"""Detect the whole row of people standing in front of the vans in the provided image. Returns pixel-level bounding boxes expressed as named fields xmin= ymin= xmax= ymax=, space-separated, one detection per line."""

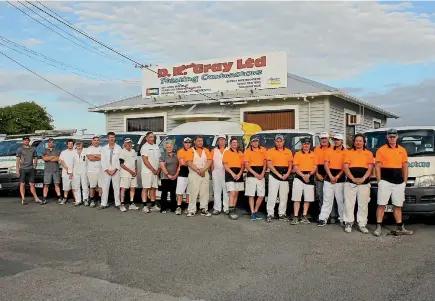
xmin=17 ymin=130 xmax=413 ymax=236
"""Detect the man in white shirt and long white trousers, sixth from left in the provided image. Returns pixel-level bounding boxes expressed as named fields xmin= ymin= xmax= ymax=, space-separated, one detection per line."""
xmin=98 ymin=132 xmax=122 ymax=209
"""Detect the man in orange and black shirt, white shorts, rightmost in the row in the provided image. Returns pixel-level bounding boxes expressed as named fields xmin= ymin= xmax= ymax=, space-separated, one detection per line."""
xmin=374 ymin=129 xmax=414 ymax=236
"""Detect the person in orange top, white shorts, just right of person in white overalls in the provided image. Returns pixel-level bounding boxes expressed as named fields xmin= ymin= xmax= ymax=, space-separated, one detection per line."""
xmin=222 ymin=138 xmax=245 ymax=220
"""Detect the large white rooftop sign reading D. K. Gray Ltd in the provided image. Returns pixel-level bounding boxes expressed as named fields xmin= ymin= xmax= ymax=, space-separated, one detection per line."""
xmin=142 ymin=52 xmax=287 ymax=98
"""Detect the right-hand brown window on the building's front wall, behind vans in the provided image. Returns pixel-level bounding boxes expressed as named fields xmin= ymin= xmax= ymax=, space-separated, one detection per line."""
xmin=244 ymin=110 xmax=295 ymax=130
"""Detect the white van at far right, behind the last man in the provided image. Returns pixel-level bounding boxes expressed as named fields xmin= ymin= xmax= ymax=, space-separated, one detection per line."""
xmin=364 ymin=126 xmax=435 ymax=215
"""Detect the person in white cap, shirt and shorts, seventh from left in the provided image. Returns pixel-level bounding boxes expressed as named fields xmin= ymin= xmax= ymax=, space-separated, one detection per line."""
xmin=119 ymin=138 xmax=139 ymax=212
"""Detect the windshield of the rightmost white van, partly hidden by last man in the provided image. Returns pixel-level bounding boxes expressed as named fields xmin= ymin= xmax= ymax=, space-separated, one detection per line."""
xmin=366 ymin=130 xmax=435 ymax=157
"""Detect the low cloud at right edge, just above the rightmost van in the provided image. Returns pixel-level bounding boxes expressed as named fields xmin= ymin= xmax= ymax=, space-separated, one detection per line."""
xmin=364 ymin=78 xmax=435 ymax=126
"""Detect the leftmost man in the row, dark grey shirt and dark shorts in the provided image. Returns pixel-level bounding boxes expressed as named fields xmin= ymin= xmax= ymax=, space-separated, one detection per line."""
xmin=16 ymin=137 xmax=41 ymax=205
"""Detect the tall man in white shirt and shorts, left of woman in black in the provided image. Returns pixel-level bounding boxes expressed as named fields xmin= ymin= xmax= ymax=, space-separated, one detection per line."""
xmin=140 ymin=132 xmax=160 ymax=213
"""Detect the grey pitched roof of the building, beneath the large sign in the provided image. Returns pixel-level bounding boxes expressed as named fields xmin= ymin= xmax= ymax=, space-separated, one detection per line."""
xmin=89 ymin=73 xmax=399 ymax=118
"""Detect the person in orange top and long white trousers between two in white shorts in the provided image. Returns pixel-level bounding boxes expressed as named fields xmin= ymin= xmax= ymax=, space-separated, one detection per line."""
xmin=266 ymin=134 xmax=293 ymax=222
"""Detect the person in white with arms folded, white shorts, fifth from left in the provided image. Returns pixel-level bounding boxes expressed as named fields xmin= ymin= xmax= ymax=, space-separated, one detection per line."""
xmin=85 ymin=136 xmax=103 ymax=208
